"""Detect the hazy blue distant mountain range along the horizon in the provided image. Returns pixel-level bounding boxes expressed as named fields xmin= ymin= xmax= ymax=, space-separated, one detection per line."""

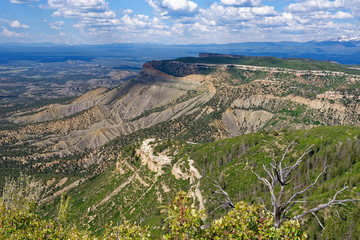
xmin=0 ymin=39 xmax=360 ymax=65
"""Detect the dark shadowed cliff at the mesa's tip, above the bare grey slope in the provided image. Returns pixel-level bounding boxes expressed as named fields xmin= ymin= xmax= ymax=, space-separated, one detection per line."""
xmin=141 ymin=60 xmax=199 ymax=77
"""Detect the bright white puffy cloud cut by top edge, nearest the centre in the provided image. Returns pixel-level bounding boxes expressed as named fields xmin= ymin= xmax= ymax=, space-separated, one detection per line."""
xmin=146 ymin=0 xmax=198 ymax=16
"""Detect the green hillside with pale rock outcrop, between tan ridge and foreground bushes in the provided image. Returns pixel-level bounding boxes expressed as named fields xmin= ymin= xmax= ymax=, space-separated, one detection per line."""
xmin=38 ymin=127 xmax=360 ymax=237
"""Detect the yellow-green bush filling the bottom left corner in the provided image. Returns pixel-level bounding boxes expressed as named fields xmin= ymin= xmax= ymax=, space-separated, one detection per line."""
xmin=0 ymin=174 xmax=90 ymax=240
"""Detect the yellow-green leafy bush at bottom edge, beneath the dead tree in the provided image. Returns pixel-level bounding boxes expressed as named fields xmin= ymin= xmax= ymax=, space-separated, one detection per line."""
xmin=163 ymin=192 xmax=306 ymax=240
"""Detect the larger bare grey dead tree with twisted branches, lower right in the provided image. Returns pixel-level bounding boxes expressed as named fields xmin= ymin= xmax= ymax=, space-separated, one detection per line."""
xmin=254 ymin=142 xmax=360 ymax=228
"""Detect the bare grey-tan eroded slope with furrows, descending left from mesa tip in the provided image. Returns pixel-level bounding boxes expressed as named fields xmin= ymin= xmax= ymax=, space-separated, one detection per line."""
xmin=3 ymin=67 xmax=215 ymax=158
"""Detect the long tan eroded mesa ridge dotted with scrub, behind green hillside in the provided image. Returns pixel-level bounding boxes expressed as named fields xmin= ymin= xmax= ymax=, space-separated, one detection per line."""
xmin=0 ymin=55 xmax=360 ymax=174
